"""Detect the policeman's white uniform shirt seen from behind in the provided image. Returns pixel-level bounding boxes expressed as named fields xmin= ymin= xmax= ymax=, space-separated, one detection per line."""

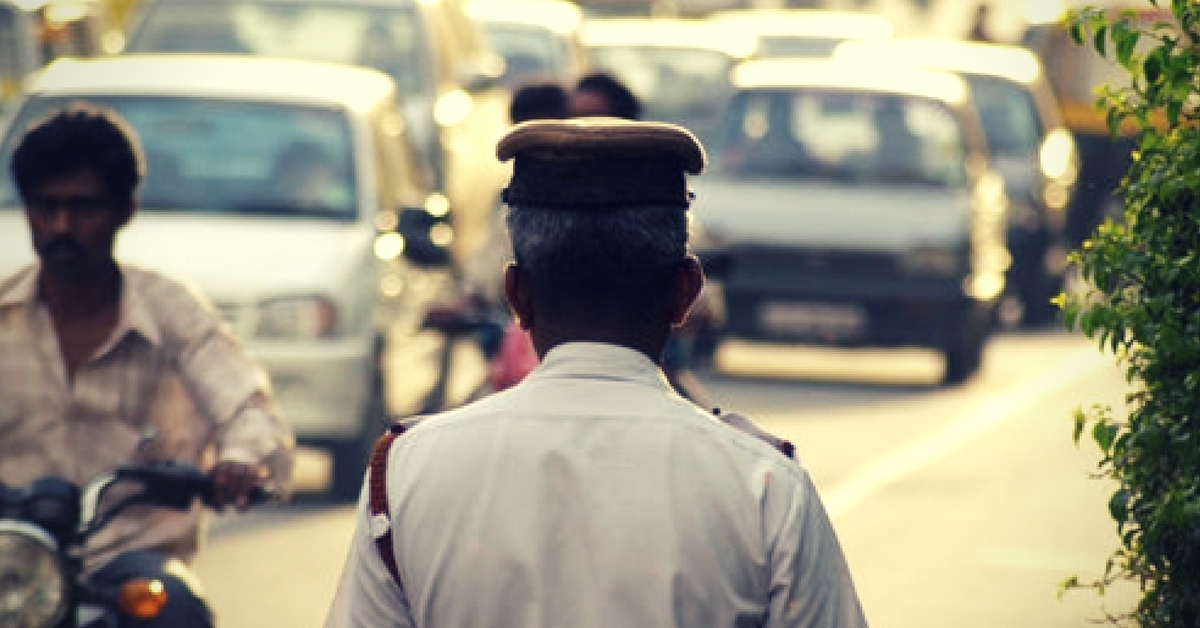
xmin=325 ymin=343 xmax=866 ymax=628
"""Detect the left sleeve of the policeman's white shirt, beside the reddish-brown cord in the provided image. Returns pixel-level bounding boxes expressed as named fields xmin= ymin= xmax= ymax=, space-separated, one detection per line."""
xmin=325 ymin=490 xmax=415 ymax=628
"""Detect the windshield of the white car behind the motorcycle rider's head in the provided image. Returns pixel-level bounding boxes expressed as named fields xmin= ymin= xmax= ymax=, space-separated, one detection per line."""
xmin=0 ymin=96 xmax=358 ymax=221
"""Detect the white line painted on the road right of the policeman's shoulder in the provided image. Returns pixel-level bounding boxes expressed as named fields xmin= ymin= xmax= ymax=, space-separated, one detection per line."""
xmin=822 ymin=346 xmax=1114 ymax=518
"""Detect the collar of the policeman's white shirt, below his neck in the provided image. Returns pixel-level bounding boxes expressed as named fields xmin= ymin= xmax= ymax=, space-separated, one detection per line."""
xmin=529 ymin=342 xmax=671 ymax=389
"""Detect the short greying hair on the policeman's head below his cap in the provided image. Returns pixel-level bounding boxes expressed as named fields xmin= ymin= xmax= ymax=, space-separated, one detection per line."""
xmin=508 ymin=207 xmax=688 ymax=319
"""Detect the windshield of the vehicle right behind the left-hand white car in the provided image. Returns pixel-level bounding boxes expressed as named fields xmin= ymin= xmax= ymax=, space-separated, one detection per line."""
xmin=128 ymin=1 xmax=434 ymax=96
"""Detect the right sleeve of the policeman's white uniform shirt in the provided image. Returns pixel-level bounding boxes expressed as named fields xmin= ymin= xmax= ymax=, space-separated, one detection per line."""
xmin=766 ymin=469 xmax=866 ymax=628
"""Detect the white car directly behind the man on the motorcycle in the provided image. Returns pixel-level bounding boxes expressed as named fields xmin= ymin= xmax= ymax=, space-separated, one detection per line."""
xmin=0 ymin=55 xmax=445 ymax=496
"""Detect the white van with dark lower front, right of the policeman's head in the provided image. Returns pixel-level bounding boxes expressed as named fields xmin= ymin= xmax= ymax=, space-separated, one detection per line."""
xmin=694 ymin=60 xmax=1008 ymax=383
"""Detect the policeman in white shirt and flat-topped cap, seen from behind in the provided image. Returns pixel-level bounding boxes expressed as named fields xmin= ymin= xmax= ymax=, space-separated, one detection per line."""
xmin=325 ymin=118 xmax=866 ymax=628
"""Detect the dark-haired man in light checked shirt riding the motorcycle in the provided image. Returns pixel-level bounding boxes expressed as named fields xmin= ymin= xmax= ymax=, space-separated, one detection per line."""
xmin=0 ymin=104 xmax=294 ymax=628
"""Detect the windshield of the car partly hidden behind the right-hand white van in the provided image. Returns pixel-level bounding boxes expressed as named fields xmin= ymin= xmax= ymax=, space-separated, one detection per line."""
xmin=965 ymin=76 xmax=1044 ymax=157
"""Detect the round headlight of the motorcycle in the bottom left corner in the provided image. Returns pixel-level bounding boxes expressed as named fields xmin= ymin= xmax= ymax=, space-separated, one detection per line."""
xmin=0 ymin=521 xmax=70 ymax=628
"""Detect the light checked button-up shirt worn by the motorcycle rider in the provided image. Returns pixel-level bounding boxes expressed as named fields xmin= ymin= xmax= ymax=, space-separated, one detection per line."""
xmin=0 ymin=264 xmax=293 ymax=569
